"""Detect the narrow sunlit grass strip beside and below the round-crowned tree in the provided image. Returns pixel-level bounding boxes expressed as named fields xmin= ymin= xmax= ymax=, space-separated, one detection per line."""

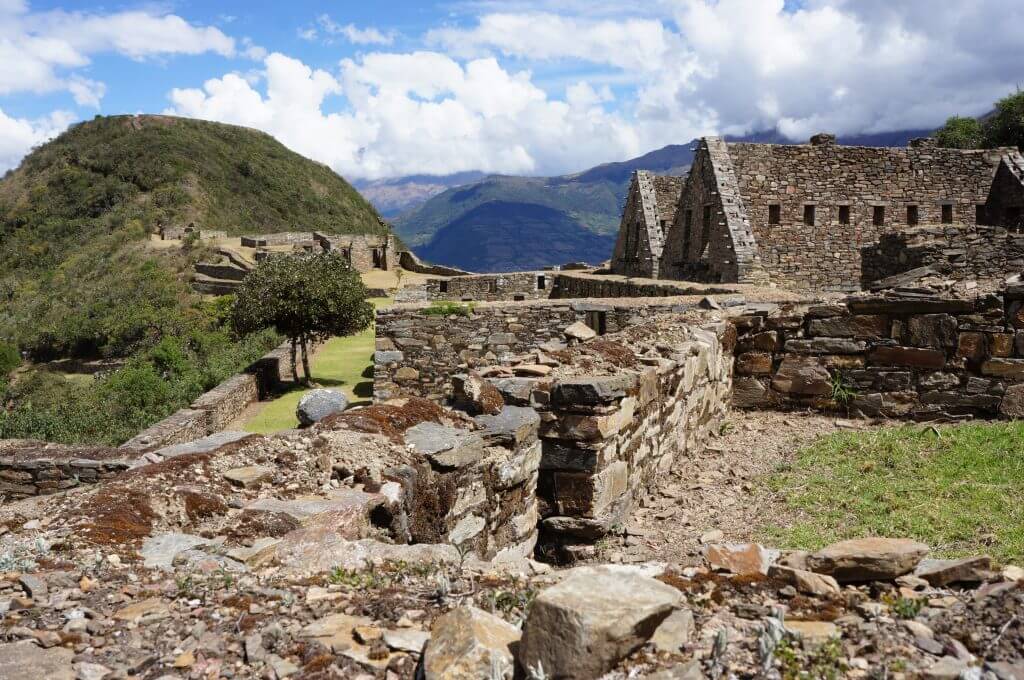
xmin=243 ymin=298 xmax=391 ymax=434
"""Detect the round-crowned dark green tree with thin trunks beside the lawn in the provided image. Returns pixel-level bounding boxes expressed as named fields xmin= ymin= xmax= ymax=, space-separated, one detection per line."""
xmin=229 ymin=253 xmax=374 ymax=382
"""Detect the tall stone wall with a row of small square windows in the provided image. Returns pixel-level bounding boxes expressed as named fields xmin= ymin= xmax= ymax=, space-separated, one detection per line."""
xmin=729 ymin=139 xmax=1007 ymax=291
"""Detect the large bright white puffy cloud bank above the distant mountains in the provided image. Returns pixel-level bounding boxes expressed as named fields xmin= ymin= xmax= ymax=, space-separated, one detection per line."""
xmin=168 ymin=52 xmax=640 ymax=178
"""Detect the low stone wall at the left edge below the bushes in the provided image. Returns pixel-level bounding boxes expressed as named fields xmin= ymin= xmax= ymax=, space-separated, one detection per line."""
xmin=0 ymin=439 xmax=130 ymax=501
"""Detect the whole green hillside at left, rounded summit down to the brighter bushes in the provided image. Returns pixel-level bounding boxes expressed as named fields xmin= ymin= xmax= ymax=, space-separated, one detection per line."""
xmin=0 ymin=116 xmax=387 ymax=443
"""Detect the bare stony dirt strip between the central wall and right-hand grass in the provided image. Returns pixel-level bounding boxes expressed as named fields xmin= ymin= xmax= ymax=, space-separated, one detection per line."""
xmin=596 ymin=411 xmax=882 ymax=565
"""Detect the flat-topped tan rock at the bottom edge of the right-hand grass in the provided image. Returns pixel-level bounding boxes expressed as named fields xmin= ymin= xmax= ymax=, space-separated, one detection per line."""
xmin=807 ymin=538 xmax=928 ymax=583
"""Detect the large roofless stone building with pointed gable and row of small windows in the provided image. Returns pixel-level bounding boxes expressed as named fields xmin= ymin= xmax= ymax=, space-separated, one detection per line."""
xmin=612 ymin=134 xmax=1024 ymax=291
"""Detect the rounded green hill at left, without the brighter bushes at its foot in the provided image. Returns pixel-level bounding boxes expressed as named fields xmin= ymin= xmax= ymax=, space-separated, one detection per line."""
xmin=0 ymin=116 xmax=387 ymax=357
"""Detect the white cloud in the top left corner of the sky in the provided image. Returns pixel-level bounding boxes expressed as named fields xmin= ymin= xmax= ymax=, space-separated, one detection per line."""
xmin=0 ymin=0 xmax=238 ymax=108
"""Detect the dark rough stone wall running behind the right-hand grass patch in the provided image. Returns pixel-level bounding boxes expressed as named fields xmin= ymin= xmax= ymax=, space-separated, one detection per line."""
xmin=733 ymin=286 xmax=1024 ymax=420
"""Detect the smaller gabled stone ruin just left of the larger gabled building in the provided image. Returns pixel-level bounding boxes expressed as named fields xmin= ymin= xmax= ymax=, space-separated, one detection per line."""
xmin=611 ymin=170 xmax=683 ymax=279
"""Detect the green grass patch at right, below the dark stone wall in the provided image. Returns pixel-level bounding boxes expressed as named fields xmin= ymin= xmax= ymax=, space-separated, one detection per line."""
xmin=763 ymin=422 xmax=1024 ymax=561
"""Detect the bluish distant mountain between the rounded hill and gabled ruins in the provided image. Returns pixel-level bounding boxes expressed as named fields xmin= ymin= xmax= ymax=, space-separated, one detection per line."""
xmin=393 ymin=130 xmax=929 ymax=271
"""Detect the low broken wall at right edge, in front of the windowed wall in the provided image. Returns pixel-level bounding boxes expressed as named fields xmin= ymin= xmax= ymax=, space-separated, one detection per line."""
xmin=861 ymin=224 xmax=1024 ymax=289
